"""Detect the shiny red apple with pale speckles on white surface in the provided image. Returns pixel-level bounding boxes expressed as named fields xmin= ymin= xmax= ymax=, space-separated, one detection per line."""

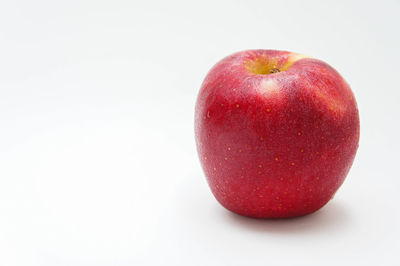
xmin=195 ymin=50 xmax=360 ymax=218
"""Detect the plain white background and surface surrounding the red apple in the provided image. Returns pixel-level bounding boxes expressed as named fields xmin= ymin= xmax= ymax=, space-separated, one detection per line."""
xmin=0 ymin=0 xmax=400 ymax=266
